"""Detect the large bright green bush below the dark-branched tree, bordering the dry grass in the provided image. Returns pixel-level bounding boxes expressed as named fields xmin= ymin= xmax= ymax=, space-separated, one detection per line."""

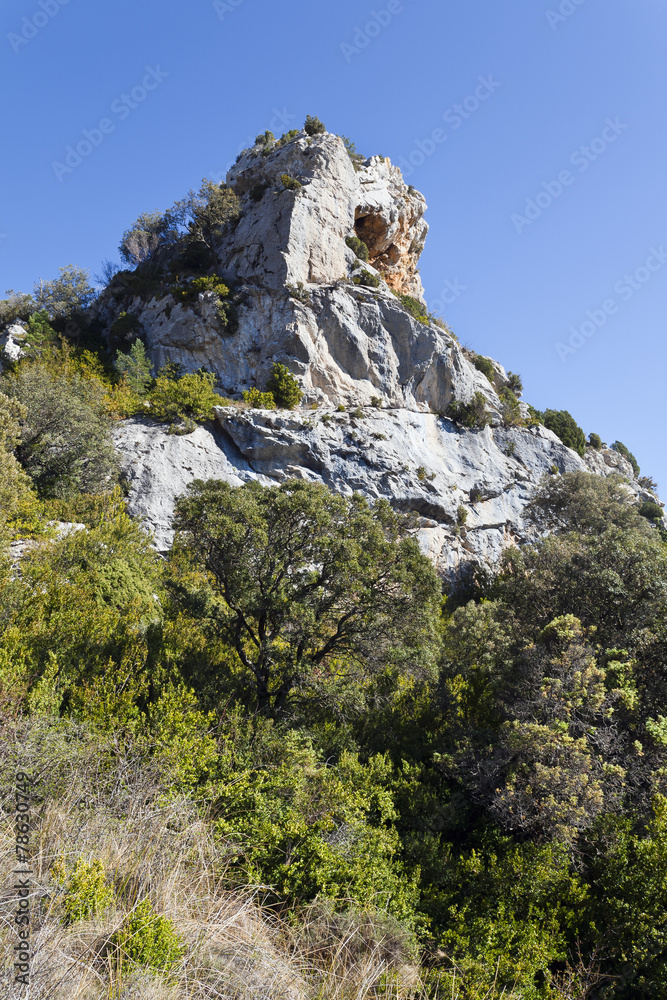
xmin=217 ymin=726 xmax=416 ymax=922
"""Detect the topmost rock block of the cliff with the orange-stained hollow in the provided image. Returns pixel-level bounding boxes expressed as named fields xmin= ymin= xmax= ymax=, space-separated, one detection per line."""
xmin=221 ymin=133 xmax=428 ymax=300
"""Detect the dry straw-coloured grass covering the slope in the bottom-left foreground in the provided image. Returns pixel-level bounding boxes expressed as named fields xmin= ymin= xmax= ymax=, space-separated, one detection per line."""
xmin=0 ymin=727 xmax=429 ymax=1000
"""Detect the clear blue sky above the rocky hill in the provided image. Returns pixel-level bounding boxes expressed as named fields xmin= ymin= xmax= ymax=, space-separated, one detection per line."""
xmin=0 ymin=0 xmax=667 ymax=493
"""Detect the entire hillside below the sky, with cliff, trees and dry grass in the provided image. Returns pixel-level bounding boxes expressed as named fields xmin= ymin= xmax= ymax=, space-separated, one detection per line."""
xmin=0 ymin=117 xmax=667 ymax=1000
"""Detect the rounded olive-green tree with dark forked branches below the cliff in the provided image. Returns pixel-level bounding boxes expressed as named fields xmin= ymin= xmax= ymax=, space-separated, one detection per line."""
xmin=175 ymin=481 xmax=440 ymax=711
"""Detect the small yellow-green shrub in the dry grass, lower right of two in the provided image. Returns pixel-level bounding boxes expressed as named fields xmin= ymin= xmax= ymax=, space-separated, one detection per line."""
xmin=109 ymin=899 xmax=185 ymax=972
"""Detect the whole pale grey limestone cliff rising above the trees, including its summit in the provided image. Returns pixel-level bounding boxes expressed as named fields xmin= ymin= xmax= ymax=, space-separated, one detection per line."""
xmin=99 ymin=127 xmax=664 ymax=581
